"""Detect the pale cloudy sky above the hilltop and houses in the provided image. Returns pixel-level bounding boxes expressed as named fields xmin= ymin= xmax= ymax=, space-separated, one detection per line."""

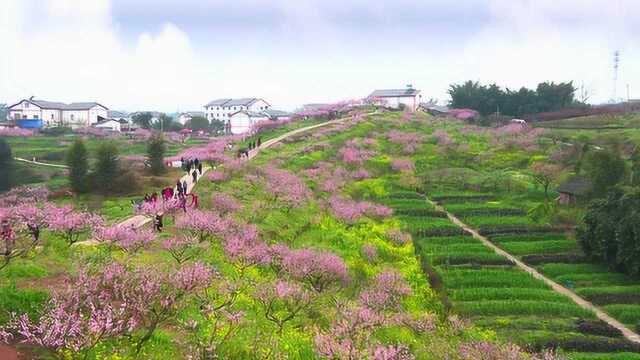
xmin=0 ymin=0 xmax=640 ymax=112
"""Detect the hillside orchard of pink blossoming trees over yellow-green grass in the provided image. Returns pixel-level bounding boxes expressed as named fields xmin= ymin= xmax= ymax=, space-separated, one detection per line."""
xmin=0 ymin=111 xmax=572 ymax=360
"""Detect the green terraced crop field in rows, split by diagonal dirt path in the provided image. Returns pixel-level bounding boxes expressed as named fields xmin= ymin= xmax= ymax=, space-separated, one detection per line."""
xmin=383 ymin=193 xmax=640 ymax=359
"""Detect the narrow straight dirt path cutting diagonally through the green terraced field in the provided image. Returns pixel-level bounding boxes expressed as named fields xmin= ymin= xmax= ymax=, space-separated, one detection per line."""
xmin=427 ymin=199 xmax=640 ymax=343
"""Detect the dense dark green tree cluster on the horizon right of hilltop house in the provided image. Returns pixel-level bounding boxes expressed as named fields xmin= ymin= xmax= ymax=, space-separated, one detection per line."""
xmin=448 ymin=81 xmax=576 ymax=116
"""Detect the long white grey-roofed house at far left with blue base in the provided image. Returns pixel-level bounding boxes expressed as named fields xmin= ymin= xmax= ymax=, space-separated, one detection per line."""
xmin=9 ymin=98 xmax=109 ymax=128
